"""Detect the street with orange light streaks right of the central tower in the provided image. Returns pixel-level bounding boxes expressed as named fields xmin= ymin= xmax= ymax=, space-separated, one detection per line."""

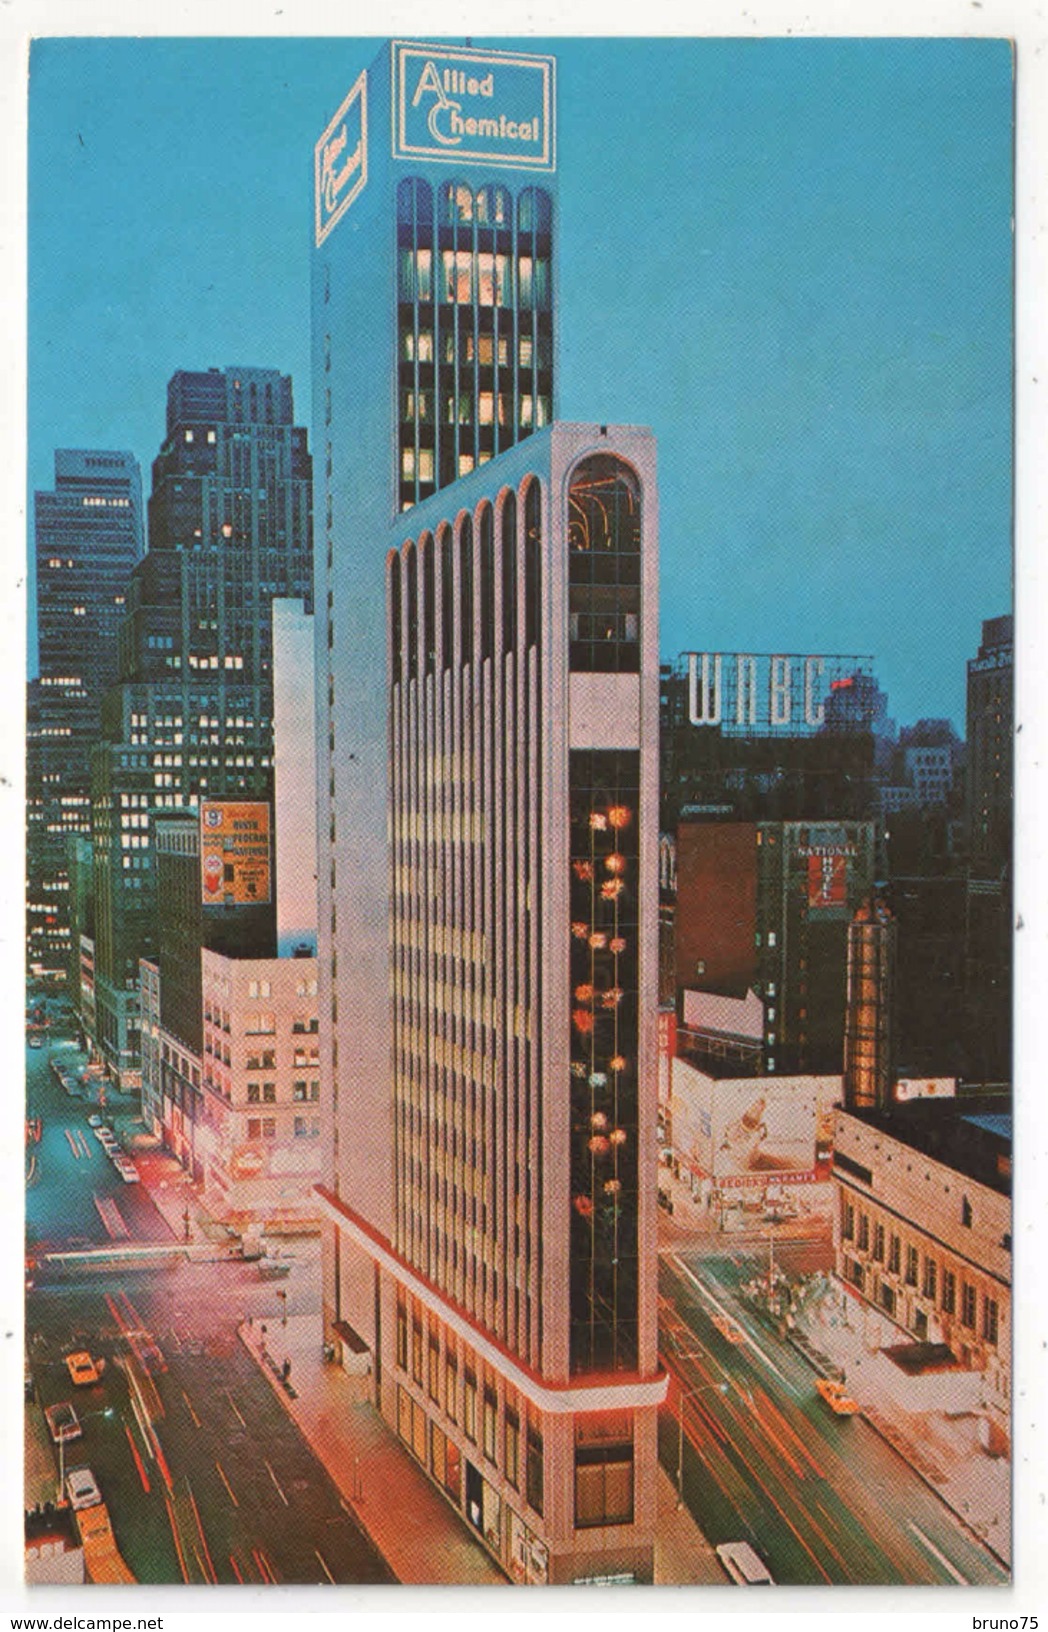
xmin=659 ymin=1245 xmax=1009 ymax=1586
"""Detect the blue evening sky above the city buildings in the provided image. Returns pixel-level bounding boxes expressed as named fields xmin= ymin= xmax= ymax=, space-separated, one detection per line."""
xmin=29 ymin=39 xmax=1012 ymax=733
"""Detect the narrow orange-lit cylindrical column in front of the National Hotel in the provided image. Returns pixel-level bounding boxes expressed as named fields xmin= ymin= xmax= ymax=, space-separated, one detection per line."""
xmin=844 ymin=901 xmax=896 ymax=1110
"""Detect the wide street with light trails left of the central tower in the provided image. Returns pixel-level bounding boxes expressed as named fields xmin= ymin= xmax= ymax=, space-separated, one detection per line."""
xmin=26 ymin=1049 xmax=392 ymax=1585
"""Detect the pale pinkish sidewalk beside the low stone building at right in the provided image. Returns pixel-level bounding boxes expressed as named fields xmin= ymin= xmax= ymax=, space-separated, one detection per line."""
xmin=797 ymin=1283 xmax=1010 ymax=1563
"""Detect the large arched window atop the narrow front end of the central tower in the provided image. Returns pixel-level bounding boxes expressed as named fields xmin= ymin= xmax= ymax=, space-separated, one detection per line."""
xmin=568 ymin=454 xmax=640 ymax=674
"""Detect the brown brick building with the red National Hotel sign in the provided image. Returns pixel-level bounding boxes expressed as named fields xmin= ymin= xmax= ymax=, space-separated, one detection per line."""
xmin=674 ymin=821 xmax=873 ymax=1075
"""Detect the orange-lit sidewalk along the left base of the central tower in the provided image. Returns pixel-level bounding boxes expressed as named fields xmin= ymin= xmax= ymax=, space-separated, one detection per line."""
xmin=240 ymin=1315 xmax=509 ymax=1586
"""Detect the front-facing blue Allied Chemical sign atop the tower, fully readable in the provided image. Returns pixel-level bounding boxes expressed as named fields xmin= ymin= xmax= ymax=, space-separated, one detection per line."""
xmin=392 ymin=41 xmax=555 ymax=170
